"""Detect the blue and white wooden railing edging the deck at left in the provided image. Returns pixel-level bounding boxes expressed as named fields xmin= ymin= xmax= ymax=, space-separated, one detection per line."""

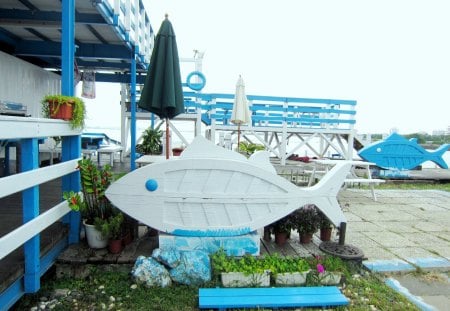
xmin=0 ymin=116 xmax=81 ymax=309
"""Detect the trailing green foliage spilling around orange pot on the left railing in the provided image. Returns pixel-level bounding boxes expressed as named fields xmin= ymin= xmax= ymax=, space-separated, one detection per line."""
xmin=41 ymin=95 xmax=86 ymax=129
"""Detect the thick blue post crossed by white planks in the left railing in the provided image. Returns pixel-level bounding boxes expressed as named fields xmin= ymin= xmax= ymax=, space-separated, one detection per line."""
xmin=20 ymin=138 xmax=40 ymax=293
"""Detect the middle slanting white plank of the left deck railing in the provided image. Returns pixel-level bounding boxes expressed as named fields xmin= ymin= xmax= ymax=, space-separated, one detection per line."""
xmin=0 ymin=159 xmax=79 ymax=198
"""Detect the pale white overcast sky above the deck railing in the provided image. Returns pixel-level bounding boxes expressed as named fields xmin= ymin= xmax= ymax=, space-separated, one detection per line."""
xmin=82 ymin=0 xmax=450 ymax=134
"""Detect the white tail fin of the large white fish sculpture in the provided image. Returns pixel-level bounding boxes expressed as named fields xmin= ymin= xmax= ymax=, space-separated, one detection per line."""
xmin=312 ymin=161 xmax=352 ymax=227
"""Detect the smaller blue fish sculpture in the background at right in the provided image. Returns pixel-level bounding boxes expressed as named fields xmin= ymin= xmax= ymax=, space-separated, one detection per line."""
xmin=358 ymin=133 xmax=450 ymax=170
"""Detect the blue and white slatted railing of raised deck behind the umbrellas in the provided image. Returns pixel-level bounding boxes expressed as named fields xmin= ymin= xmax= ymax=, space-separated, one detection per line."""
xmin=184 ymin=92 xmax=356 ymax=130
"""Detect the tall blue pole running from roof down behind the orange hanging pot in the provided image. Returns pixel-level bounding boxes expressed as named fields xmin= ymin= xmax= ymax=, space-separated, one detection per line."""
xmin=61 ymin=0 xmax=81 ymax=244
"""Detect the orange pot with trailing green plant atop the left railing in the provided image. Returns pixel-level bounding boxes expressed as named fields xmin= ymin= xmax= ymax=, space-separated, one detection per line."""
xmin=41 ymin=95 xmax=86 ymax=129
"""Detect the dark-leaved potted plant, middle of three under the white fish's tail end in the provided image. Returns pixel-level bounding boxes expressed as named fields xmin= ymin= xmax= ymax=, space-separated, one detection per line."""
xmin=293 ymin=204 xmax=320 ymax=244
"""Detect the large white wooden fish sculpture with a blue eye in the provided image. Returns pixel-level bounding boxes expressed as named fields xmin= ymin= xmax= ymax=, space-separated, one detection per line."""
xmin=106 ymin=136 xmax=351 ymax=236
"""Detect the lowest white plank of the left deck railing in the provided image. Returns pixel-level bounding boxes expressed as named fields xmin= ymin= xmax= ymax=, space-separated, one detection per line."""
xmin=0 ymin=201 xmax=70 ymax=260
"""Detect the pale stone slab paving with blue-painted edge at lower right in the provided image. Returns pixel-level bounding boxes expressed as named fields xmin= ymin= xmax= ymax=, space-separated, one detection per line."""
xmin=339 ymin=189 xmax=450 ymax=310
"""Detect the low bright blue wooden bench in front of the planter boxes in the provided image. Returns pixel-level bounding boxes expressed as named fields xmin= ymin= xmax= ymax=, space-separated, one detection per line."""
xmin=198 ymin=286 xmax=349 ymax=310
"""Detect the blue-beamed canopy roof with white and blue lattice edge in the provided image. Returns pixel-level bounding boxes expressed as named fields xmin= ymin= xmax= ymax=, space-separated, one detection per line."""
xmin=0 ymin=0 xmax=154 ymax=82
